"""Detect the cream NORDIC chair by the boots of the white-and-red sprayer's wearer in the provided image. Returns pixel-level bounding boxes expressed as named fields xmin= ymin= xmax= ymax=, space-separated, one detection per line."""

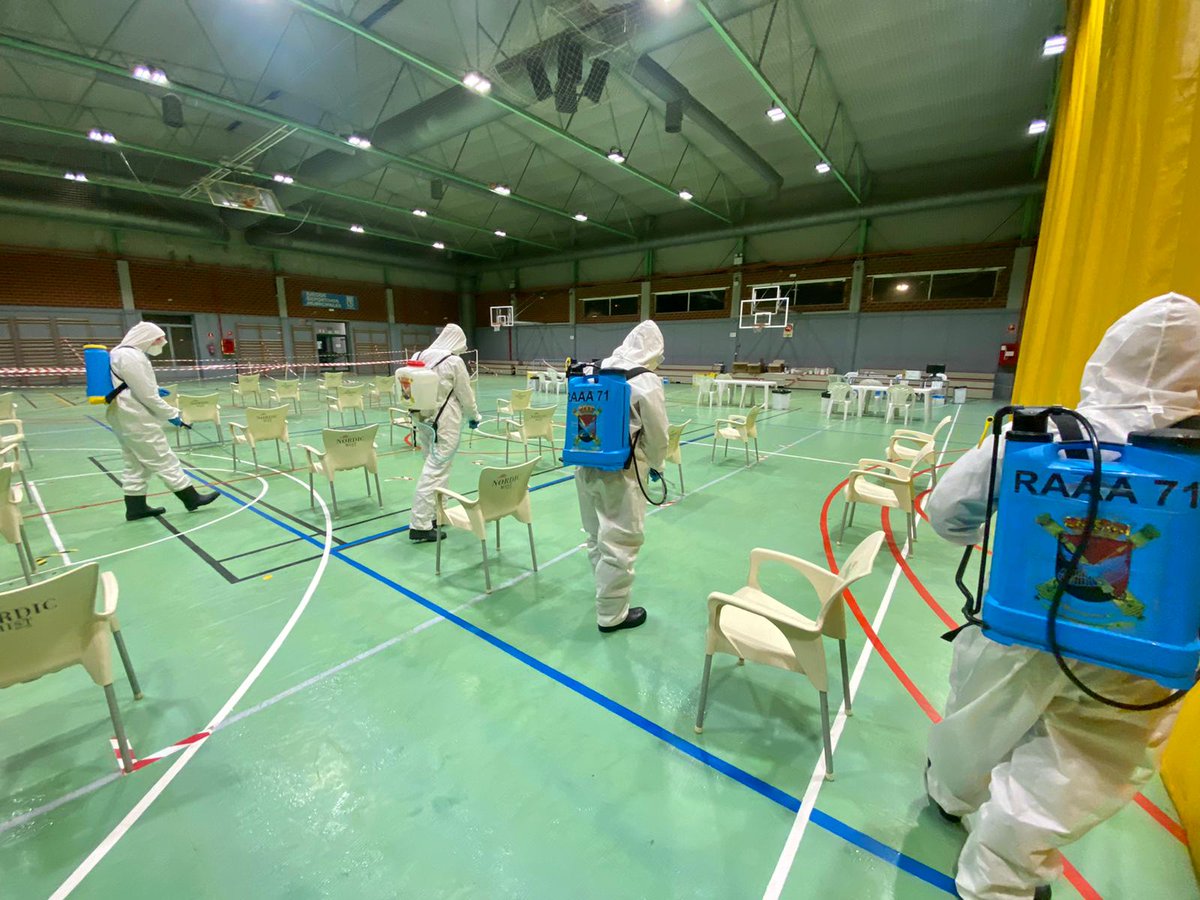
xmin=434 ymin=460 xmax=538 ymax=594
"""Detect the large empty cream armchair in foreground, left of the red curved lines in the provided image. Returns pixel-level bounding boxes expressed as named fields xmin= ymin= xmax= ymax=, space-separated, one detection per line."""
xmin=696 ymin=532 xmax=883 ymax=780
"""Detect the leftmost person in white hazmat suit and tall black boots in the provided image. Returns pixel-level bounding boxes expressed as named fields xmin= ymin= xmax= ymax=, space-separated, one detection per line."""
xmin=104 ymin=322 xmax=220 ymax=521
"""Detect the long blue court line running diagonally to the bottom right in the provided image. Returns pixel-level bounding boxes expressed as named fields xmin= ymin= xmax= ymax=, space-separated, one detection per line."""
xmin=182 ymin=475 xmax=956 ymax=895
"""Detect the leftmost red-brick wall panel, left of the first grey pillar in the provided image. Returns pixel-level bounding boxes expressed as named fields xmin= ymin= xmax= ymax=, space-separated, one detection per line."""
xmin=0 ymin=248 xmax=121 ymax=310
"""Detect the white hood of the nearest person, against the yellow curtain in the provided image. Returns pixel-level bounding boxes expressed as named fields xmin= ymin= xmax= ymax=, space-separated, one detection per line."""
xmin=1079 ymin=294 xmax=1200 ymax=443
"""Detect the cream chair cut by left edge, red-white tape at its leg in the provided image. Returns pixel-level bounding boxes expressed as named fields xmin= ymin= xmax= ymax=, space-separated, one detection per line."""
xmin=0 ymin=563 xmax=142 ymax=774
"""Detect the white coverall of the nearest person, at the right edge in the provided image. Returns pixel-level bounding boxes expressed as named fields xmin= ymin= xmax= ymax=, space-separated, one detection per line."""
xmin=926 ymin=294 xmax=1200 ymax=900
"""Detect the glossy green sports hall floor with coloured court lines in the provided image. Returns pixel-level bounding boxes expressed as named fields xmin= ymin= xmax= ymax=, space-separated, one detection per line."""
xmin=0 ymin=377 xmax=1200 ymax=900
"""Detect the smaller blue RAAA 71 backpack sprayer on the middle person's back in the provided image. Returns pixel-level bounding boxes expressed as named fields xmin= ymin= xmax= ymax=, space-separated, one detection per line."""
xmin=563 ymin=361 xmax=667 ymax=506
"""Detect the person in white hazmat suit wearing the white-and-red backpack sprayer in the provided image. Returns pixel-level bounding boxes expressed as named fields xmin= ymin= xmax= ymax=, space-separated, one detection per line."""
xmin=408 ymin=325 xmax=479 ymax=544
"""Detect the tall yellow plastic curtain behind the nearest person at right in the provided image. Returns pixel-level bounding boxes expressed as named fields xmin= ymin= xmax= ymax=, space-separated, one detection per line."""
xmin=1014 ymin=0 xmax=1200 ymax=872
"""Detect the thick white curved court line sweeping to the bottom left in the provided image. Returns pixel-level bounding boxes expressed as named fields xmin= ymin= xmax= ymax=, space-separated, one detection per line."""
xmin=50 ymin=472 xmax=334 ymax=900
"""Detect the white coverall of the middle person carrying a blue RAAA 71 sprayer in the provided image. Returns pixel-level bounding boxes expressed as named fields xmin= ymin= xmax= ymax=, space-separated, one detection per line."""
xmin=575 ymin=320 xmax=668 ymax=626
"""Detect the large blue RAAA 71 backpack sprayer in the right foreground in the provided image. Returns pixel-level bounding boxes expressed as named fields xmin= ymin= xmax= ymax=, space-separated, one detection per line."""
xmin=947 ymin=407 xmax=1200 ymax=710
